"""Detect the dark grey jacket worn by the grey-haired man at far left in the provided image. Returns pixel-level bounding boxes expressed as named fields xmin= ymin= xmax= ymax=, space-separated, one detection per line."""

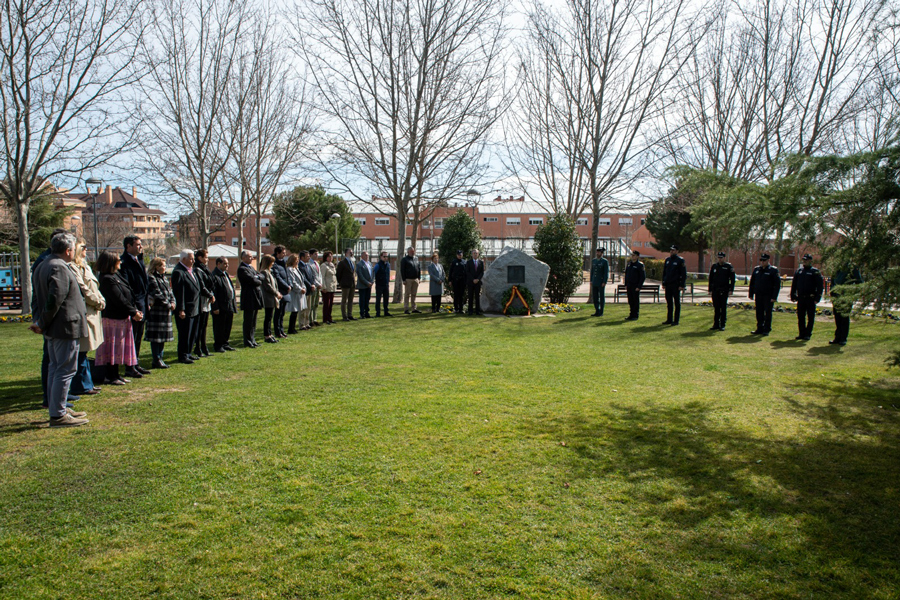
xmin=32 ymin=255 xmax=87 ymax=340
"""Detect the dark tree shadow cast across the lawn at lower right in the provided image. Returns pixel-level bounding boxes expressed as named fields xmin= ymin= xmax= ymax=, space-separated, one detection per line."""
xmin=536 ymin=382 xmax=900 ymax=596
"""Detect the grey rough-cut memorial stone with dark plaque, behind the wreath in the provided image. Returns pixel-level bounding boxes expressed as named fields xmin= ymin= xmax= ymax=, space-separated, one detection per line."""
xmin=481 ymin=246 xmax=550 ymax=313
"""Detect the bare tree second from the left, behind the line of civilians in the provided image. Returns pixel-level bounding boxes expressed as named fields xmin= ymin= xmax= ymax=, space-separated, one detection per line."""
xmin=141 ymin=0 xmax=249 ymax=247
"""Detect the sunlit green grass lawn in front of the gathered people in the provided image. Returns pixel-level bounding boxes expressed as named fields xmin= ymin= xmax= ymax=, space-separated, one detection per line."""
xmin=0 ymin=303 xmax=900 ymax=599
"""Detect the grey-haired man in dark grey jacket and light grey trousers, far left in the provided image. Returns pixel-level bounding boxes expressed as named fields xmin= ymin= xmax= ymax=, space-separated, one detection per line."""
xmin=30 ymin=233 xmax=88 ymax=427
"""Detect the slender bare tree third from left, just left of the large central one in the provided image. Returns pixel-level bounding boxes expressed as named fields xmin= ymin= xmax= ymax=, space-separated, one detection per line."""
xmin=227 ymin=12 xmax=313 ymax=255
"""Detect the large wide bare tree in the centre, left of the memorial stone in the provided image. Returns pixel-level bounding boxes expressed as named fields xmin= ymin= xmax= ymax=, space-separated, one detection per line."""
xmin=295 ymin=0 xmax=506 ymax=300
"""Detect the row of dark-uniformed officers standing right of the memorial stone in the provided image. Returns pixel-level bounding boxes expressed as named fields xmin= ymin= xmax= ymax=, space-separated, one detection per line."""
xmin=590 ymin=245 xmax=862 ymax=346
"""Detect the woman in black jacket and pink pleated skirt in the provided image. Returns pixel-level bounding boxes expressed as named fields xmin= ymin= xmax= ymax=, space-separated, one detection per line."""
xmin=94 ymin=250 xmax=144 ymax=385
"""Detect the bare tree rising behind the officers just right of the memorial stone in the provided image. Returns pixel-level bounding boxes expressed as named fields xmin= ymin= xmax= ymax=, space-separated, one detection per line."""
xmin=511 ymin=0 xmax=704 ymax=254
